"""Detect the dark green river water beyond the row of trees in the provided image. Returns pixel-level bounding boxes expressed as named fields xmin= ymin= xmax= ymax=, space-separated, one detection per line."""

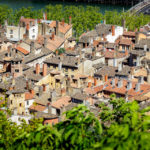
xmin=0 ymin=0 xmax=130 ymax=13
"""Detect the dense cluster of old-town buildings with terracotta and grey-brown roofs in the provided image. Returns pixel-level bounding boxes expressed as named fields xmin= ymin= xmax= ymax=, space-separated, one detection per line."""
xmin=0 ymin=13 xmax=150 ymax=124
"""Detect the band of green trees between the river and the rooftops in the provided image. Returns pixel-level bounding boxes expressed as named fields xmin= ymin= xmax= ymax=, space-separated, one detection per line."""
xmin=0 ymin=5 xmax=150 ymax=37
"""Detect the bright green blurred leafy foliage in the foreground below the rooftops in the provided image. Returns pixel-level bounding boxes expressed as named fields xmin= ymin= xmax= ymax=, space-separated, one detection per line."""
xmin=0 ymin=95 xmax=150 ymax=150
